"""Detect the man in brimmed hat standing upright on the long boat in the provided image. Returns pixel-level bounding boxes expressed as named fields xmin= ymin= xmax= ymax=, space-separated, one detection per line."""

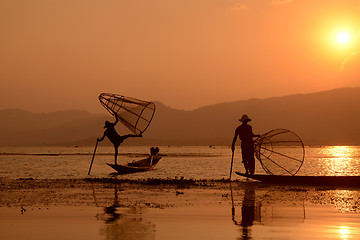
xmin=231 ymin=114 xmax=260 ymax=175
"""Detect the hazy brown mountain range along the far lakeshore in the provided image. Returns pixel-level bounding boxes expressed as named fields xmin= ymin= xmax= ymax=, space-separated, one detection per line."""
xmin=0 ymin=88 xmax=360 ymax=146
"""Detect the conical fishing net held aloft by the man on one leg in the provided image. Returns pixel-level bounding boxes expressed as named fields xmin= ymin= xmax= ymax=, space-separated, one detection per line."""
xmin=99 ymin=93 xmax=155 ymax=134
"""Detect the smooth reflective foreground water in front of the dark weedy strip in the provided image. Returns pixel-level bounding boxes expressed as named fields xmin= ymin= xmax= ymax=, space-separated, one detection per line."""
xmin=0 ymin=183 xmax=360 ymax=240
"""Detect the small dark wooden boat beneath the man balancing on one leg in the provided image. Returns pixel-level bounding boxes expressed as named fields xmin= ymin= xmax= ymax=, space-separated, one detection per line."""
xmin=106 ymin=156 xmax=161 ymax=174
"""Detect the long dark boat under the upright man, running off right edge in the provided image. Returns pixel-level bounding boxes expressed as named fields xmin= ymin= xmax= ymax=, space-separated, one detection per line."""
xmin=235 ymin=172 xmax=360 ymax=187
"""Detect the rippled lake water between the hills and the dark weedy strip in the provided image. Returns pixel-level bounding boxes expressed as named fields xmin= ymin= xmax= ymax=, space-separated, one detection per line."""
xmin=0 ymin=146 xmax=360 ymax=179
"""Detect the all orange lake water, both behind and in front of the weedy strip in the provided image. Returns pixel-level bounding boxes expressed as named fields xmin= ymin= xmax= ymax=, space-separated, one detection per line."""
xmin=0 ymin=146 xmax=360 ymax=240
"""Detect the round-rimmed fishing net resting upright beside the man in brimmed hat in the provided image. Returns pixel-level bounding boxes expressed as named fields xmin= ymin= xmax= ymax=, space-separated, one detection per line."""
xmin=255 ymin=129 xmax=305 ymax=175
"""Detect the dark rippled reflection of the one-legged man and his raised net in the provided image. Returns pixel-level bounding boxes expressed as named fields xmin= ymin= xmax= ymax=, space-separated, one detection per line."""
xmin=96 ymin=185 xmax=155 ymax=240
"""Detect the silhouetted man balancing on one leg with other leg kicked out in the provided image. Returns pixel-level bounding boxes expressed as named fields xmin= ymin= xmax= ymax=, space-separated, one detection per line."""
xmin=97 ymin=115 xmax=142 ymax=165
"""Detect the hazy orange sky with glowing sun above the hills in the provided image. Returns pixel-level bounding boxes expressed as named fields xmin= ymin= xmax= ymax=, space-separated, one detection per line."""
xmin=0 ymin=0 xmax=360 ymax=112
